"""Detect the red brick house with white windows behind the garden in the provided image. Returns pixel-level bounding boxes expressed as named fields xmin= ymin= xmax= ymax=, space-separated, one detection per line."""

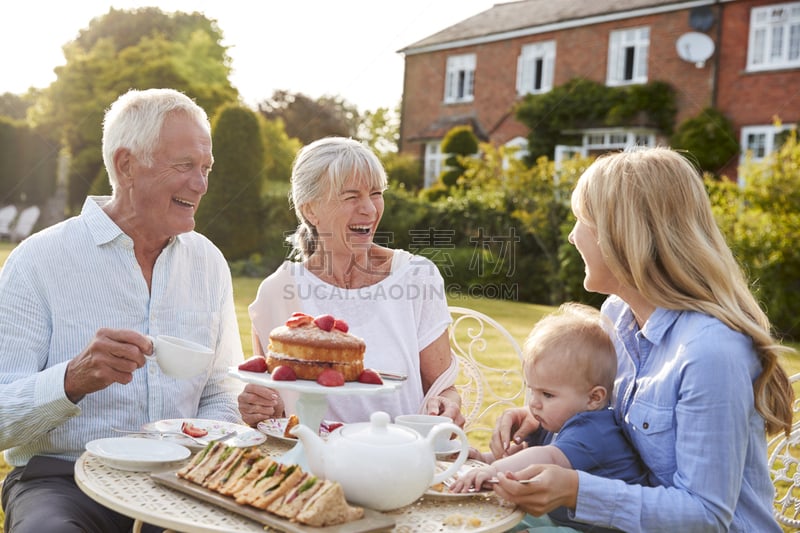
xmin=399 ymin=0 xmax=800 ymax=186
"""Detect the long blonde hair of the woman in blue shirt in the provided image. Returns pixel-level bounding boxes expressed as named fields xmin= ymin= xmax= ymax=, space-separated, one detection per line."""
xmin=572 ymin=144 xmax=794 ymax=435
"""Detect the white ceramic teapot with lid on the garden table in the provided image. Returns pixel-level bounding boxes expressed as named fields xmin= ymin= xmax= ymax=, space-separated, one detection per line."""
xmin=291 ymin=411 xmax=469 ymax=511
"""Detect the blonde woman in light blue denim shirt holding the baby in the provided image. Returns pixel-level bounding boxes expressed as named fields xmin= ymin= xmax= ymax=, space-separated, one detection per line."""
xmin=492 ymin=148 xmax=792 ymax=533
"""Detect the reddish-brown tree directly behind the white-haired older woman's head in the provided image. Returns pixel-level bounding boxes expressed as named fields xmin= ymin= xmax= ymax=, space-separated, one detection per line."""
xmin=258 ymin=91 xmax=359 ymax=145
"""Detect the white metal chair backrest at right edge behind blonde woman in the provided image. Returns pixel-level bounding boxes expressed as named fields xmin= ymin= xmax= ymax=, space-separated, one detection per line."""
xmin=768 ymin=374 xmax=800 ymax=530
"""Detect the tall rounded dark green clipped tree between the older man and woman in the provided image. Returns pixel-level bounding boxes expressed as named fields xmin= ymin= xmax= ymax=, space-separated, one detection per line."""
xmin=197 ymin=104 xmax=264 ymax=260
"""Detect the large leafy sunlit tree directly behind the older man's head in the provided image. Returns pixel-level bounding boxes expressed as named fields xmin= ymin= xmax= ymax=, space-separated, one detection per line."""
xmin=29 ymin=8 xmax=238 ymax=209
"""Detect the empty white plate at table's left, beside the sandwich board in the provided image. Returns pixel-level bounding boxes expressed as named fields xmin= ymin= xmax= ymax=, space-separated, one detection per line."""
xmin=86 ymin=437 xmax=192 ymax=472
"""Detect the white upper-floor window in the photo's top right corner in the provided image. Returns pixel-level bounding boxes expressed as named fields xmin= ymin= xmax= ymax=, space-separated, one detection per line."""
xmin=747 ymin=2 xmax=800 ymax=71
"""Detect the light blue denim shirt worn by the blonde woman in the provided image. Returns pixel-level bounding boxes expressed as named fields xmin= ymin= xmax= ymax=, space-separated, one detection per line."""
xmin=575 ymin=296 xmax=781 ymax=533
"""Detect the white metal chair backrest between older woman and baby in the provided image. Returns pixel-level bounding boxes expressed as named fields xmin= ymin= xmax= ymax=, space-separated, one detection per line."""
xmin=449 ymin=306 xmax=527 ymax=444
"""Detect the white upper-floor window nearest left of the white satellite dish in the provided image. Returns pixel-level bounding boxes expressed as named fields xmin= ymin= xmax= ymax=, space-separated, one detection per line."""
xmin=606 ymin=26 xmax=650 ymax=86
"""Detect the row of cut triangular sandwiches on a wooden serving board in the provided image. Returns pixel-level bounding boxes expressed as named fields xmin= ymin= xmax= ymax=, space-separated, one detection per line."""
xmin=150 ymin=443 xmax=395 ymax=533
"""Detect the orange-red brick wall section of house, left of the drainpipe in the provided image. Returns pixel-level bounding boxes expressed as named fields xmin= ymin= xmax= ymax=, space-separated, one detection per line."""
xmin=401 ymin=6 xmax=716 ymax=154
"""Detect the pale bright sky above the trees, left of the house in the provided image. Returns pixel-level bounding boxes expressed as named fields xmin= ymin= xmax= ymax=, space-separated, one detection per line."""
xmin=0 ymin=0 xmax=500 ymax=111
